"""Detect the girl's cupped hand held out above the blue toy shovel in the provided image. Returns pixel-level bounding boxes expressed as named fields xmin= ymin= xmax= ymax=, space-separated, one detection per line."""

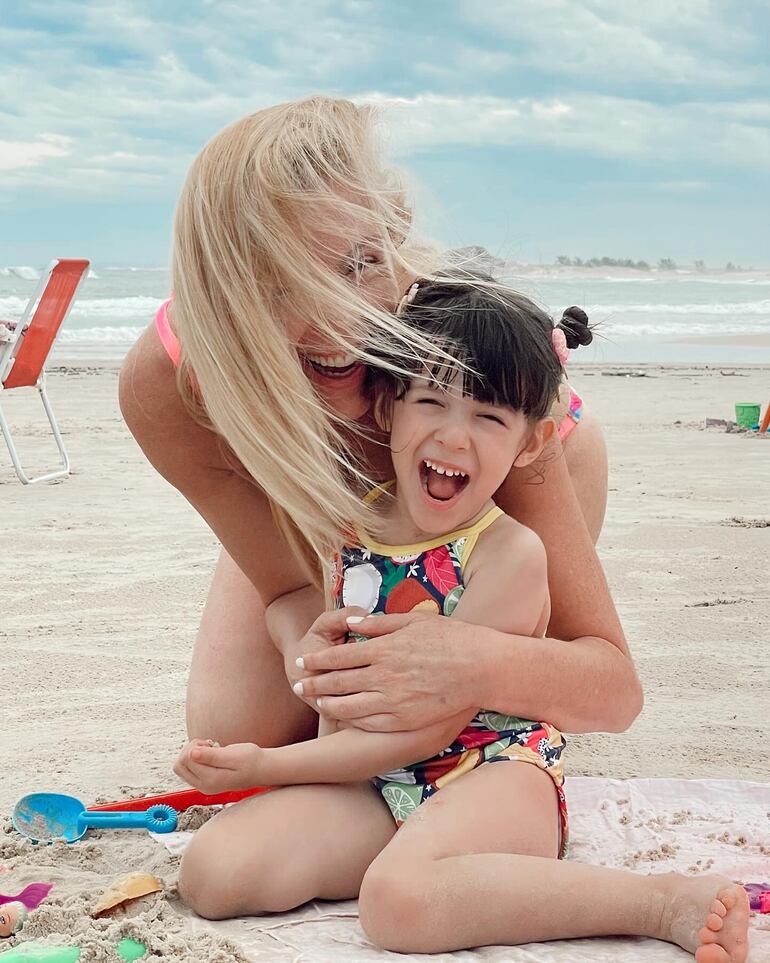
xmin=174 ymin=739 xmax=268 ymax=795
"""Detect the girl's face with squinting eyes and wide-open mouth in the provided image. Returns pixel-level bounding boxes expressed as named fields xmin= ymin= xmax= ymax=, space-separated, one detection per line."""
xmin=390 ymin=377 xmax=550 ymax=536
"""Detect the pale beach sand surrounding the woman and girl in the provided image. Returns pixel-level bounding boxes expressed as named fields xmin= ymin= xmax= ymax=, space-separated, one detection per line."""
xmin=0 ymin=366 xmax=770 ymax=961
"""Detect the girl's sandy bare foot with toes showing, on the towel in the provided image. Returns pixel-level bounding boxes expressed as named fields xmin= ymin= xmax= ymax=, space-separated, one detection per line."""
xmin=661 ymin=873 xmax=749 ymax=963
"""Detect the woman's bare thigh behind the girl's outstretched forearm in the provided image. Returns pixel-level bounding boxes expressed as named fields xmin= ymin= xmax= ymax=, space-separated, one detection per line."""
xmin=187 ymin=549 xmax=318 ymax=746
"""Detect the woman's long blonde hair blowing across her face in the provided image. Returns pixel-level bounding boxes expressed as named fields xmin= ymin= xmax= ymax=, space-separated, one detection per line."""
xmin=172 ymin=97 xmax=440 ymax=584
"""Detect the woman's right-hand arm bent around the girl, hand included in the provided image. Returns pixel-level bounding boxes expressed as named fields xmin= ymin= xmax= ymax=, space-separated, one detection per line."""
xmin=292 ymin=440 xmax=642 ymax=732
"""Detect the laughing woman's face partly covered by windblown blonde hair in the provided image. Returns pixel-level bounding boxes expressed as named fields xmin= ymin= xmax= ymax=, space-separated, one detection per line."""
xmin=283 ymin=211 xmax=401 ymax=419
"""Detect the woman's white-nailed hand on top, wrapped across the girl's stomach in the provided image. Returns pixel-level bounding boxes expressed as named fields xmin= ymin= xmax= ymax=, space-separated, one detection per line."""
xmin=292 ymin=609 xmax=481 ymax=732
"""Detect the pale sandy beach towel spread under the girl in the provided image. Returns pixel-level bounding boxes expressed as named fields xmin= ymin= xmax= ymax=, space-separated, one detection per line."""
xmin=157 ymin=777 xmax=770 ymax=963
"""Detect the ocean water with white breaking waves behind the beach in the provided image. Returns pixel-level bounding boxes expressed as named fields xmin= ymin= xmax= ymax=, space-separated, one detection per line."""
xmin=0 ymin=266 xmax=770 ymax=365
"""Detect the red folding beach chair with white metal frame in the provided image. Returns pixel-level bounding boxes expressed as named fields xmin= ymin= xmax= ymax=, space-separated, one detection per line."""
xmin=0 ymin=259 xmax=89 ymax=485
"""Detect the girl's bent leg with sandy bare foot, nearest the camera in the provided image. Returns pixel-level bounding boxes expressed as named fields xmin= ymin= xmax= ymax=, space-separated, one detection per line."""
xmin=359 ymin=762 xmax=748 ymax=963
